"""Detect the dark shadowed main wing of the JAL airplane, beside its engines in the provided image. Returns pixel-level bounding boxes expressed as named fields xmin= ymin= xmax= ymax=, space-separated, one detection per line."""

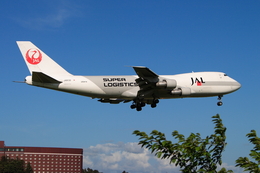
xmin=133 ymin=66 xmax=159 ymax=97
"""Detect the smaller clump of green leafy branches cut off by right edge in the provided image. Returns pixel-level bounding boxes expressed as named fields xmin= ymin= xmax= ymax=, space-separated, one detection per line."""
xmin=236 ymin=130 xmax=260 ymax=173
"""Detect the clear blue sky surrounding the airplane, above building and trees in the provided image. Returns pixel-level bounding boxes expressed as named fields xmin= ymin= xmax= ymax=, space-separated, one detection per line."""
xmin=0 ymin=0 xmax=260 ymax=173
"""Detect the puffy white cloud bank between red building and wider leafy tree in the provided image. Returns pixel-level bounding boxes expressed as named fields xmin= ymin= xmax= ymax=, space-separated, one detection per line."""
xmin=84 ymin=142 xmax=179 ymax=173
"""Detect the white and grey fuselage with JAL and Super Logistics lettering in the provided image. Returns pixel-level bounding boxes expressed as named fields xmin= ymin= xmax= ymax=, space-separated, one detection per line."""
xmin=26 ymin=72 xmax=241 ymax=99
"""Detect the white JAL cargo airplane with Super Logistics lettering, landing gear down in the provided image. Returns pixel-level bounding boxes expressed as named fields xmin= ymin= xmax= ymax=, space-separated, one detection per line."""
xmin=17 ymin=41 xmax=241 ymax=111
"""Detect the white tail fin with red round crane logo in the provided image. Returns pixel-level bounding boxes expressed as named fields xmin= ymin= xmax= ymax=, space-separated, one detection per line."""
xmin=16 ymin=41 xmax=71 ymax=77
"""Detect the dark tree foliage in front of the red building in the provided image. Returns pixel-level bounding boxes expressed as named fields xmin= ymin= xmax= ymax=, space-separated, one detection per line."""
xmin=0 ymin=156 xmax=33 ymax=173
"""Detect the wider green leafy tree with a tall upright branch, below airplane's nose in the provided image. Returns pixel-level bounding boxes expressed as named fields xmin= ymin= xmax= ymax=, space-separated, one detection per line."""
xmin=133 ymin=114 xmax=232 ymax=173
